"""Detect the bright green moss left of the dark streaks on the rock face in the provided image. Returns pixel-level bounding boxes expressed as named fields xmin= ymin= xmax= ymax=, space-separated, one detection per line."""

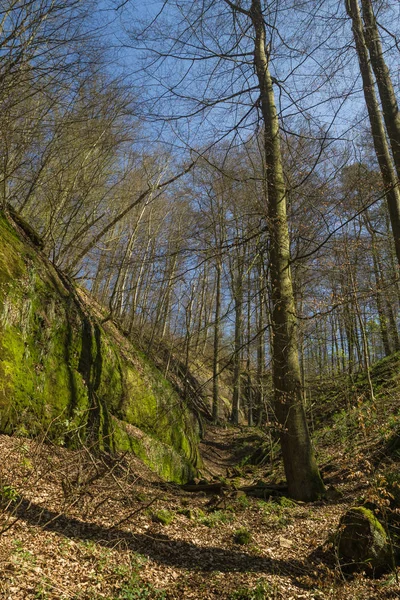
xmin=0 ymin=264 xmax=86 ymax=435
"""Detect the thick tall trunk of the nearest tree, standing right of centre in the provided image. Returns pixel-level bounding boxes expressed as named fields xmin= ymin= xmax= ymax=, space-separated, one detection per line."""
xmin=249 ymin=0 xmax=324 ymax=501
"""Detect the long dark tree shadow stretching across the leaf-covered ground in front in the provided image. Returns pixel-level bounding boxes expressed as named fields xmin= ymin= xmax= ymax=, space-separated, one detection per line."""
xmin=7 ymin=499 xmax=312 ymax=582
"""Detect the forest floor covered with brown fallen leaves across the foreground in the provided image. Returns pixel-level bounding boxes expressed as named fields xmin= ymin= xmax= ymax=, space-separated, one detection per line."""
xmin=0 ymin=427 xmax=400 ymax=600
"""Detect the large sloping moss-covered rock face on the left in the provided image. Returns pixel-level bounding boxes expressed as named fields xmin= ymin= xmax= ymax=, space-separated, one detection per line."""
xmin=0 ymin=213 xmax=200 ymax=482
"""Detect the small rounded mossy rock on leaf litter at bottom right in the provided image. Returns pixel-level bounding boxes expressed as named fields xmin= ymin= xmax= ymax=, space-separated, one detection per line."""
xmin=336 ymin=506 xmax=390 ymax=571
